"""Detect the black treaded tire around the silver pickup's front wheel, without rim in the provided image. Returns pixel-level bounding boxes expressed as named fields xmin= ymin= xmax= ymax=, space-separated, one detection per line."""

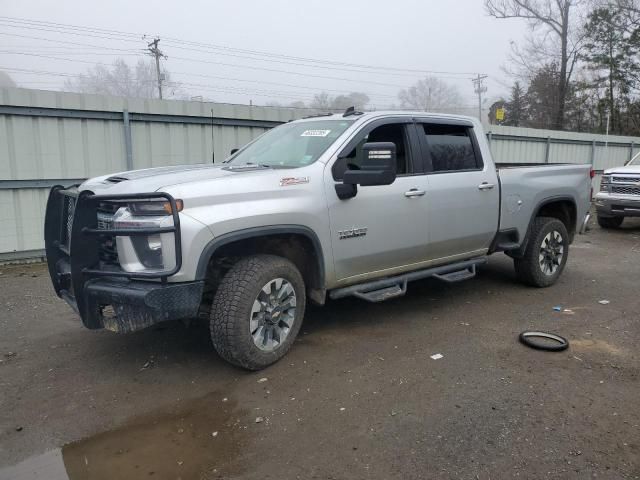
xmin=209 ymin=255 xmax=306 ymax=370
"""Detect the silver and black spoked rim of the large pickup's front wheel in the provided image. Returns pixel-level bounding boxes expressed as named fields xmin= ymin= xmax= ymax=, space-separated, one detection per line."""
xmin=249 ymin=278 xmax=296 ymax=352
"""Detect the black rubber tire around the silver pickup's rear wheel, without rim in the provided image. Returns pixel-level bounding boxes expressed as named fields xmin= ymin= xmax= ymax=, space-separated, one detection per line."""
xmin=513 ymin=217 xmax=569 ymax=288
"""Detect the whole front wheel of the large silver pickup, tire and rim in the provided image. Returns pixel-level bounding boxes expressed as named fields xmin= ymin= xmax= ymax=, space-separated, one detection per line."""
xmin=209 ymin=255 xmax=306 ymax=370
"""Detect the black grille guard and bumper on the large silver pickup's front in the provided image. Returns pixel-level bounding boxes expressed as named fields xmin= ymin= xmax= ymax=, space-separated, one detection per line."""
xmin=45 ymin=187 xmax=204 ymax=333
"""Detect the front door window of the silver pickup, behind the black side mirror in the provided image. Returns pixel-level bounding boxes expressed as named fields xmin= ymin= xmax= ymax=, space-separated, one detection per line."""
xmin=333 ymin=123 xmax=411 ymax=180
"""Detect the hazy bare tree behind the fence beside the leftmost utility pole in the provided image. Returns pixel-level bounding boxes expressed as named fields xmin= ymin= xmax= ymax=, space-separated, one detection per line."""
xmin=65 ymin=58 xmax=185 ymax=98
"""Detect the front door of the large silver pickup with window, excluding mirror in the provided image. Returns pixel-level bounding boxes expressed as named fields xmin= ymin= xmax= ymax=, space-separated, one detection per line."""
xmin=324 ymin=117 xmax=428 ymax=284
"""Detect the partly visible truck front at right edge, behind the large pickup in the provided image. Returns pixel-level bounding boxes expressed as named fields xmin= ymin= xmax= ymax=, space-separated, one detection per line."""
xmin=595 ymin=153 xmax=640 ymax=228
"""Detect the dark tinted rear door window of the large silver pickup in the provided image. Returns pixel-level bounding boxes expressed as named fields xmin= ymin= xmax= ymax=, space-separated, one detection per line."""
xmin=422 ymin=123 xmax=482 ymax=172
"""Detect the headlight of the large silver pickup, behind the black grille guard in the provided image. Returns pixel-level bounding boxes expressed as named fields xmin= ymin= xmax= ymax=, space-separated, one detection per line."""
xmin=113 ymin=200 xmax=183 ymax=272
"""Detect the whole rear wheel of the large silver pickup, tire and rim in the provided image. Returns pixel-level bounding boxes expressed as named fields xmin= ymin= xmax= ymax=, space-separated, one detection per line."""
xmin=513 ymin=217 xmax=569 ymax=287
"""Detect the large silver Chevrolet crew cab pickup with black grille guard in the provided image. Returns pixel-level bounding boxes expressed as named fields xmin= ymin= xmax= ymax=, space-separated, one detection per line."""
xmin=45 ymin=109 xmax=591 ymax=370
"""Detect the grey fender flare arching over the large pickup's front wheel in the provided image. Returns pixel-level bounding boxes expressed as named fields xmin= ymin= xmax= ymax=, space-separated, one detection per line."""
xmin=196 ymin=225 xmax=325 ymax=285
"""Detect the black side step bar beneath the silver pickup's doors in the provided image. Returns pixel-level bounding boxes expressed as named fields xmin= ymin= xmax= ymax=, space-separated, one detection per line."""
xmin=329 ymin=257 xmax=487 ymax=302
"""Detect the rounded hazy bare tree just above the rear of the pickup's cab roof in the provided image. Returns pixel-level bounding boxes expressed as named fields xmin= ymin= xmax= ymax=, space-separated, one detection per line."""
xmin=398 ymin=77 xmax=462 ymax=112
